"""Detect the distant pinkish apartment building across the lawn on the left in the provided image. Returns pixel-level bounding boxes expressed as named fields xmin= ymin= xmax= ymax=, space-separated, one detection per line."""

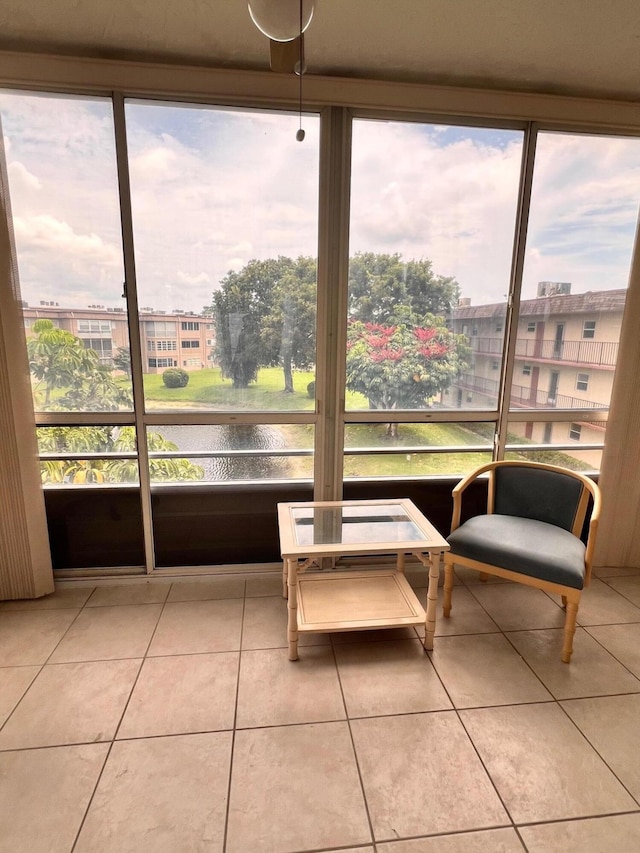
xmin=23 ymin=301 xmax=215 ymax=373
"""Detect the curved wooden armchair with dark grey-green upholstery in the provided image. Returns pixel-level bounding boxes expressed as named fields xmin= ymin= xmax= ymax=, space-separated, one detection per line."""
xmin=443 ymin=461 xmax=601 ymax=663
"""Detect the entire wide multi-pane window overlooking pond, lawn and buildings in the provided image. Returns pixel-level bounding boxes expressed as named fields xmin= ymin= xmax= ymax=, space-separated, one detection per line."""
xmin=0 ymin=85 xmax=640 ymax=565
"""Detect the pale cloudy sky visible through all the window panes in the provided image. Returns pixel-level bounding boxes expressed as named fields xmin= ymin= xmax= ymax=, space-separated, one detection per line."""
xmin=0 ymin=92 xmax=640 ymax=311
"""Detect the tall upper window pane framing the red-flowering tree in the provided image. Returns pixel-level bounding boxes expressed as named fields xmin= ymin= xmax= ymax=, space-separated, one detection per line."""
xmin=346 ymin=120 xmax=522 ymax=410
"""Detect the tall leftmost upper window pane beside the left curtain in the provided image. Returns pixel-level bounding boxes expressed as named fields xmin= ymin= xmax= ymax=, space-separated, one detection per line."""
xmin=0 ymin=92 xmax=132 ymax=412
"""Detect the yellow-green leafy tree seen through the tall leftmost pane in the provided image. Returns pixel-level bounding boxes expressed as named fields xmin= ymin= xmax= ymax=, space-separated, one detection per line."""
xmin=27 ymin=319 xmax=133 ymax=412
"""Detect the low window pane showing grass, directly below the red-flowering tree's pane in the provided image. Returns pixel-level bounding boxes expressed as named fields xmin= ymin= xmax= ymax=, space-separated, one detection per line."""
xmin=344 ymin=423 xmax=494 ymax=478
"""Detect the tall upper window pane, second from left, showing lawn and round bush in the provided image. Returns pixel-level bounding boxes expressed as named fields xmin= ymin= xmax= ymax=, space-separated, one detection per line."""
xmin=126 ymin=102 xmax=319 ymax=411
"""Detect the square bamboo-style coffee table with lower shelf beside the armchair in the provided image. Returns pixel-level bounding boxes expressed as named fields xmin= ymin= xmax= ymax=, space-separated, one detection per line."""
xmin=278 ymin=498 xmax=449 ymax=660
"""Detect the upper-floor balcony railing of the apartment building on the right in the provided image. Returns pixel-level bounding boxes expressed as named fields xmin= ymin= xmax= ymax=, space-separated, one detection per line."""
xmin=469 ymin=337 xmax=618 ymax=367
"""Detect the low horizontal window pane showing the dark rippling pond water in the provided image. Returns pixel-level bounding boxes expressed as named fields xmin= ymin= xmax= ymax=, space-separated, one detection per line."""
xmin=147 ymin=424 xmax=313 ymax=483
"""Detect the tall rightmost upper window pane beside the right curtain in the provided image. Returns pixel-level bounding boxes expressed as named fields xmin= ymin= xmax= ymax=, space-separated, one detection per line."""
xmin=511 ymin=133 xmax=640 ymax=432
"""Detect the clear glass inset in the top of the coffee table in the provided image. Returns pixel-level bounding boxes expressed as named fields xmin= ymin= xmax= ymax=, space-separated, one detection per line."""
xmin=292 ymin=503 xmax=425 ymax=546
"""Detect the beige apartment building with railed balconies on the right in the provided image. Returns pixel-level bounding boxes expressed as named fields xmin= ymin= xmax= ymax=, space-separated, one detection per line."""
xmin=443 ymin=281 xmax=626 ymax=464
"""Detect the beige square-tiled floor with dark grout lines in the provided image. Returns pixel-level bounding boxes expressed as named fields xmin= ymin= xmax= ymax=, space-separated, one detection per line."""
xmin=0 ymin=569 xmax=640 ymax=853
